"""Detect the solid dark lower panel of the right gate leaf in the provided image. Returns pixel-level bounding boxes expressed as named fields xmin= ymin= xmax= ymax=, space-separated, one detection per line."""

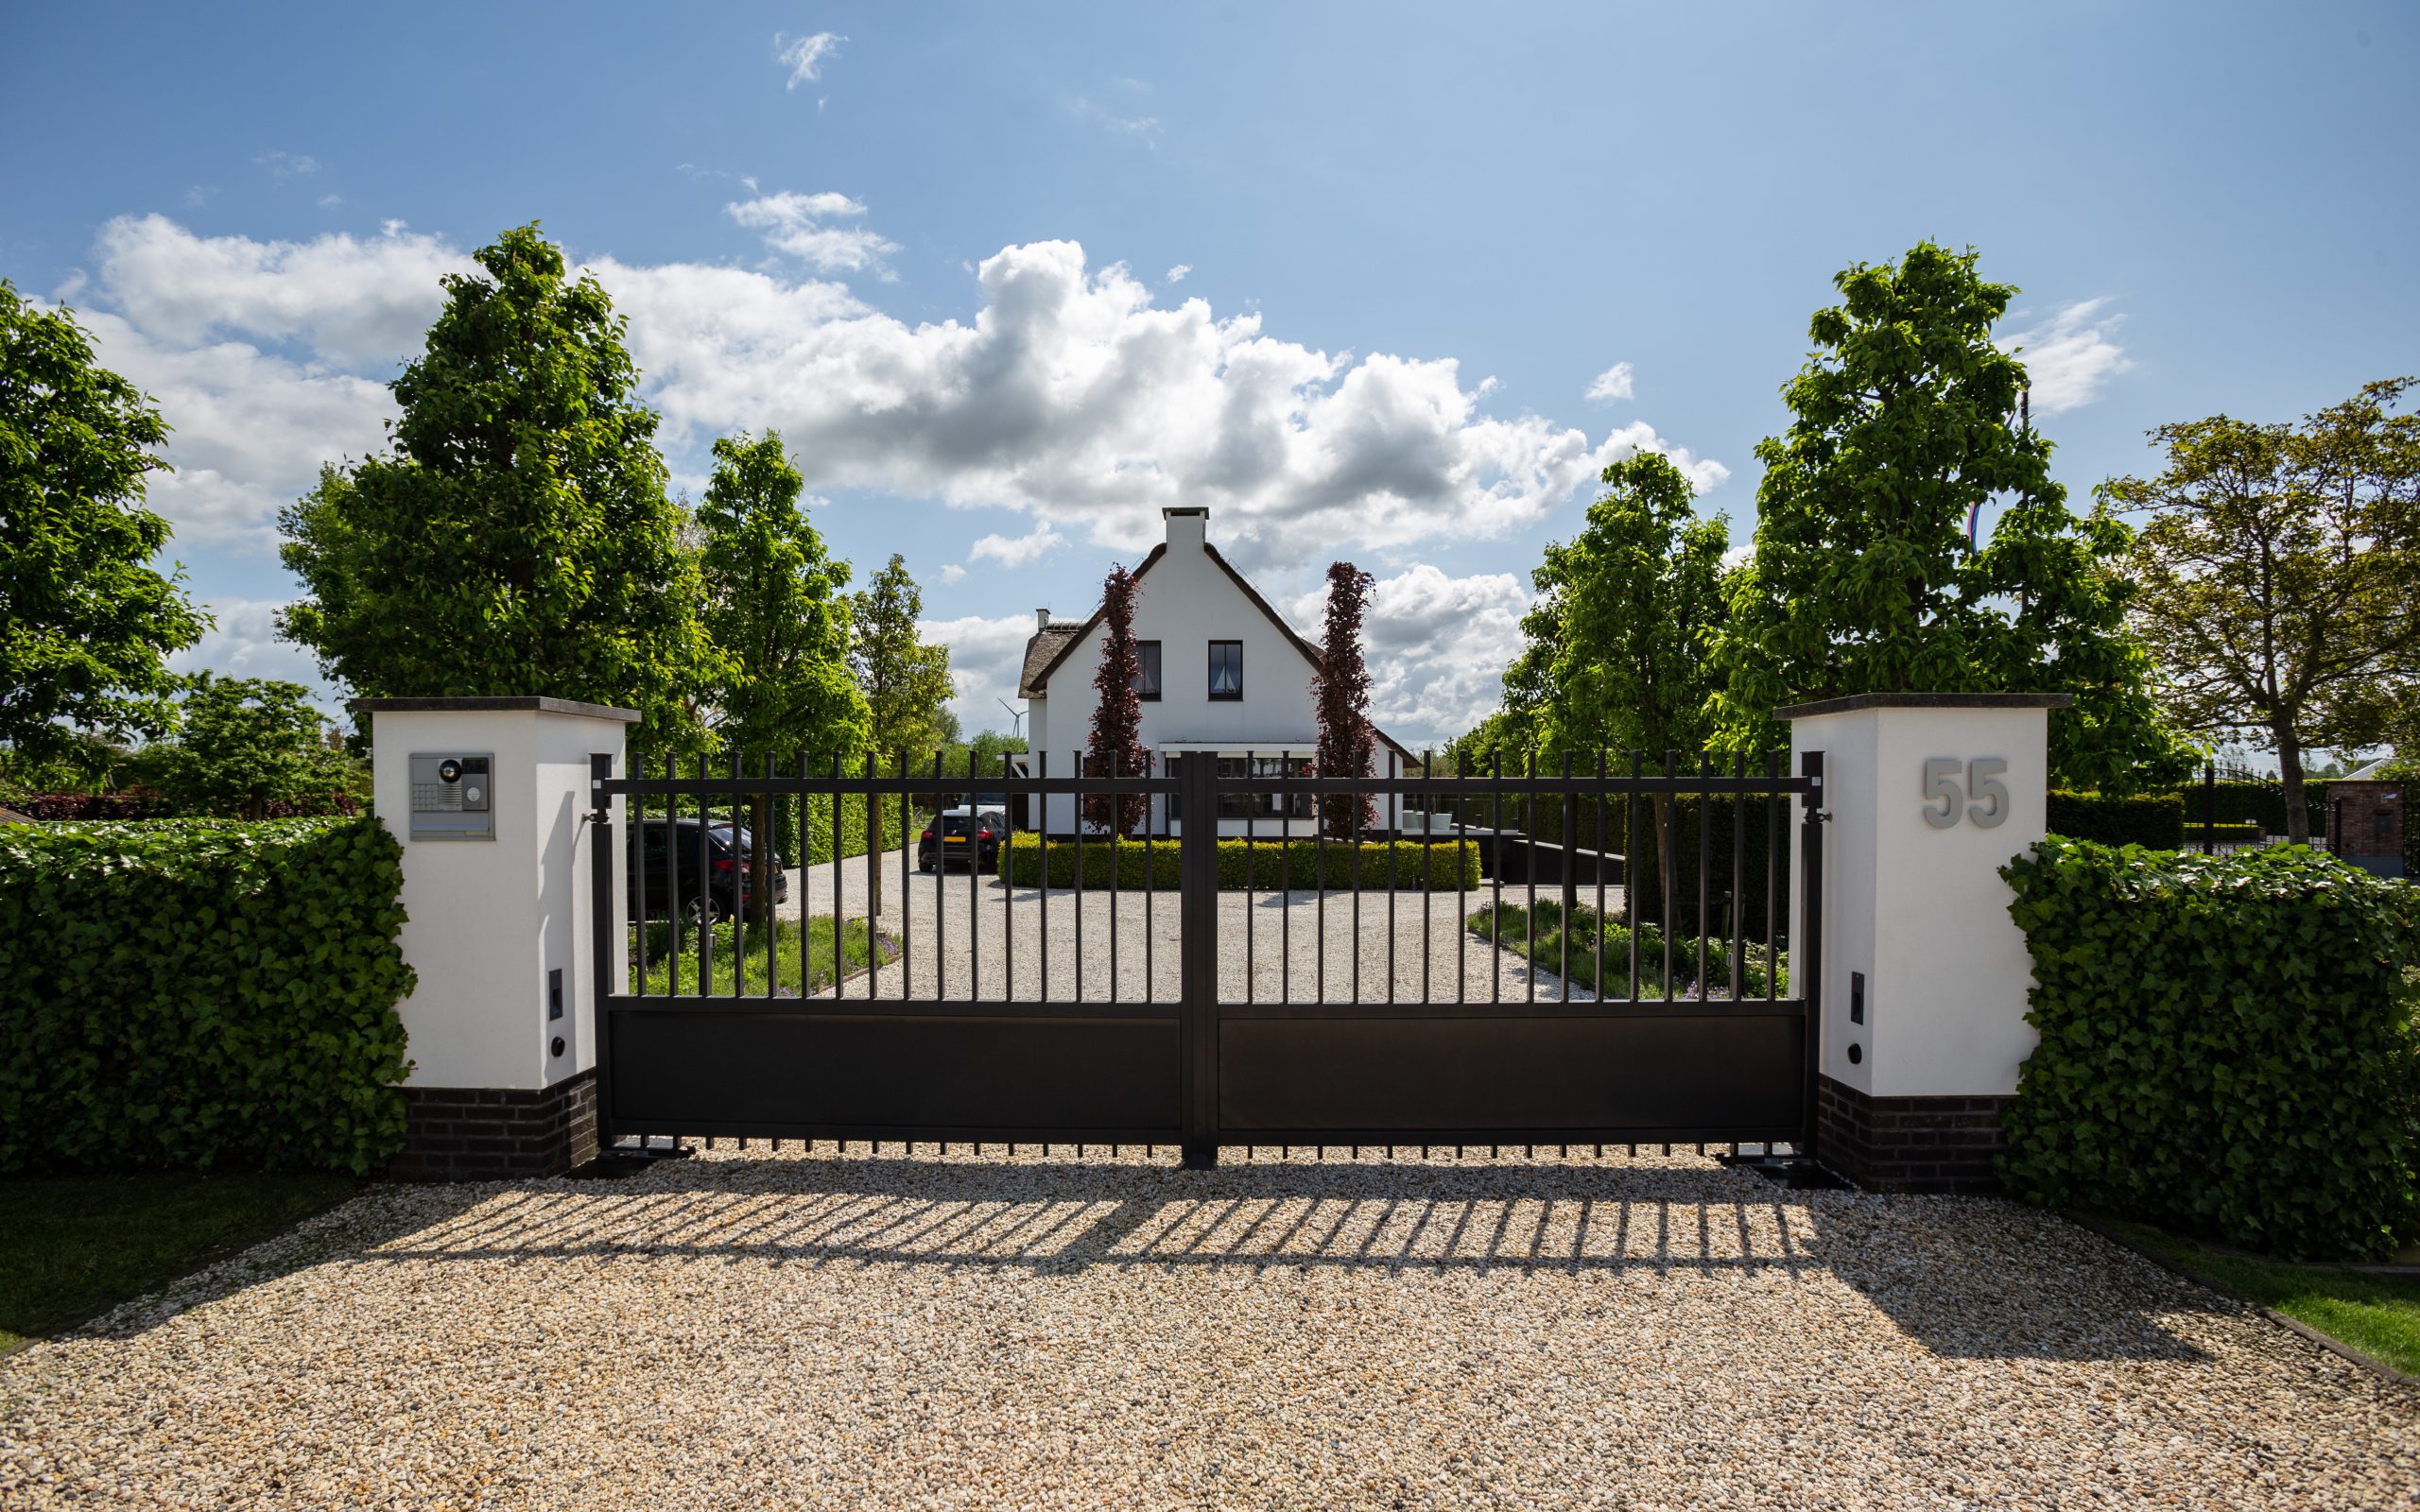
xmin=1218 ymin=1002 xmax=1807 ymax=1144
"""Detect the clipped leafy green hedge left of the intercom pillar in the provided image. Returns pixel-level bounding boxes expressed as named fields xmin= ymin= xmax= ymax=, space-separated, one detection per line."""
xmin=0 ymin=820 xmax=411 ymax=1174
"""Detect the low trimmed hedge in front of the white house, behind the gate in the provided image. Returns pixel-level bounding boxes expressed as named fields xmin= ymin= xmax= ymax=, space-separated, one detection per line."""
xmin=999 ymin=834 xmax=1478 ymax=893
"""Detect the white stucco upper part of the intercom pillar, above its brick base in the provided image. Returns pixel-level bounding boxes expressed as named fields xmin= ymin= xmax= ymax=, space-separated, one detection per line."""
xmin=355 ymin=699 xmax=636 ymax=1091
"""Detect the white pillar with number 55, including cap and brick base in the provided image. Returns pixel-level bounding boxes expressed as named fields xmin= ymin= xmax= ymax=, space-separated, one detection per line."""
xmin=1776 ymin=692 xmax=2069 ymax=1191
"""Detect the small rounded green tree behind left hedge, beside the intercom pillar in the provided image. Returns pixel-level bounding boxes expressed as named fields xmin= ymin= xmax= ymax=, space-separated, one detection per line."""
xmin=138 ymin=673 xmax=354 ymax=820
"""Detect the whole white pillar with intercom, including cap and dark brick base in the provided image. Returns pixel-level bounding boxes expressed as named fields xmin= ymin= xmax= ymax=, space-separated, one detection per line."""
xmin=354 ymin=696 xmax=639 ymax=1180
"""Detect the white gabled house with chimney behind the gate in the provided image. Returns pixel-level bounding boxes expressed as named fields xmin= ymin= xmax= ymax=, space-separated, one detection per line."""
xmin=1016 ymin=508 xmax=1418 ymax=839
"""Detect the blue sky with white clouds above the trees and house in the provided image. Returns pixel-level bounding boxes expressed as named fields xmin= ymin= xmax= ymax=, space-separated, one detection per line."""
xmin=0 ymin=5 xmax=2420 ymax=740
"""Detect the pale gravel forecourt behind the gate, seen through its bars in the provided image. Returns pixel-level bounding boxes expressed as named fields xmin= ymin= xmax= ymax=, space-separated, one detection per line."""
xmin=784 ymin=859 xmax=1621 ymax=1002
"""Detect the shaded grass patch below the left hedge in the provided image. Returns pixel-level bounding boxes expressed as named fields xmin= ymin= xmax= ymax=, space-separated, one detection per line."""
xmin=0 ymin=1171 xmax=360 ymax=1349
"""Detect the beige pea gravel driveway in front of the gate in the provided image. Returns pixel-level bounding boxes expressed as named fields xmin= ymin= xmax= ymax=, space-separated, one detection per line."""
xmin=0 ymin=1142 xmax=2420 ymax=1509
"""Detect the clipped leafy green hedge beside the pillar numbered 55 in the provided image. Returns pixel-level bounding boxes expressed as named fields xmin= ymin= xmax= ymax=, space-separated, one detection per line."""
xmin=2001 ymin=839 xmax=2420 ymax=1258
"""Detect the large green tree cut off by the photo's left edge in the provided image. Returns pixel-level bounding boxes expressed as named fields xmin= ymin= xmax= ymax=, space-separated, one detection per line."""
xmin=0 ymin=281 xmax=211 ymax=762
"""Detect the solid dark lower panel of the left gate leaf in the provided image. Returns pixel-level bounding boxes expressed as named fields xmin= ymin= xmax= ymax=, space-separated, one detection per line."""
xmin=602 ymin=999 xmax=1181 ymax=1144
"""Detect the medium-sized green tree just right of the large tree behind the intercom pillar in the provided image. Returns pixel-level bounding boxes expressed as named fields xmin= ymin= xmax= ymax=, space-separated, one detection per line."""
xmin=695 ymin=431 xmax=866 ymax=921
